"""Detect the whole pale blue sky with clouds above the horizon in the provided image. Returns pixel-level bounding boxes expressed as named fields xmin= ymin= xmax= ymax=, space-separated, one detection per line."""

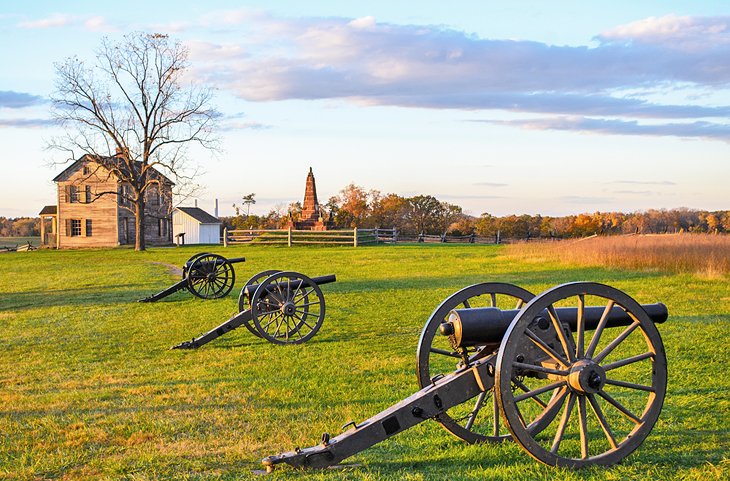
xmin=0 ymin=0 xmax=730 ymax=216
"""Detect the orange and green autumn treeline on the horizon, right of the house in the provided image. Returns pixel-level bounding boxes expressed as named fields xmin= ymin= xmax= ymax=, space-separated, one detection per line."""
xmin=221 ymin=184 xmax=730 ymax=239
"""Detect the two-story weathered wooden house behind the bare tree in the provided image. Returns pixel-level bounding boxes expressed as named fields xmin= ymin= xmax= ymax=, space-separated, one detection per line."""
xmin=41 ymin=156 xmax=174 ymax=249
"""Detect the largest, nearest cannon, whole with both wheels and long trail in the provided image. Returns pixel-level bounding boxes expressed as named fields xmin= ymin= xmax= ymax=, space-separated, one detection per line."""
xmin=262 ymin=282 xmax=668 ymax=471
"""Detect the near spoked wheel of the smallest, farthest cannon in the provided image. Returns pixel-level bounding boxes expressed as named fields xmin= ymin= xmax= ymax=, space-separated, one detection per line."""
xmin=185 ymin=253 xmax=236 ymax=299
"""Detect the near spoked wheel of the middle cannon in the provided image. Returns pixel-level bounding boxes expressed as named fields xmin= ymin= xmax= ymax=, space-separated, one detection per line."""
xmin=251 ymin=271 xmax=325 ymax=344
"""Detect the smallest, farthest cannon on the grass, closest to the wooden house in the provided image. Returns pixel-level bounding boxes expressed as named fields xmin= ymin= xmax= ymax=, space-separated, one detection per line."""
xmin=139 ymin=252 xmax=246 ymax=302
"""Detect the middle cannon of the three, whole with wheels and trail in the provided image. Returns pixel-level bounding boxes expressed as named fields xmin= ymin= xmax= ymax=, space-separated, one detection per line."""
xmin=172 ymin=270 xmax=337 ymax=349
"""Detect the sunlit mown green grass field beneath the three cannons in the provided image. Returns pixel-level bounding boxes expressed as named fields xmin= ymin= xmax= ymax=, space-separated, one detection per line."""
xmin=0 ymin=245 xmax=730 ymax=481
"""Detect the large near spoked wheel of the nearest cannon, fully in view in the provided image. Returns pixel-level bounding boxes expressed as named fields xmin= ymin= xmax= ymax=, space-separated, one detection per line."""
xmin=496 ymin=282 xmax=667 ymax=468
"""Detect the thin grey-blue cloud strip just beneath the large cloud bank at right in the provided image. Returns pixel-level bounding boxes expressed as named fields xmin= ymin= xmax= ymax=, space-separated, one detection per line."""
xmin=475 ymin=116 xmax=730 ymax=143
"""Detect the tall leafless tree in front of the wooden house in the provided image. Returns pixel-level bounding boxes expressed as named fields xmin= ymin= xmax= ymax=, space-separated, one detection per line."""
xmin=51 ymin=33 xmax=217 ymax=250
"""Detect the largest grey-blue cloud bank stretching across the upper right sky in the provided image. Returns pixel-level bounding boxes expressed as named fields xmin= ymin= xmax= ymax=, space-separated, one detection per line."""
xmin=193 ymin=16 xmax=730 ymax=111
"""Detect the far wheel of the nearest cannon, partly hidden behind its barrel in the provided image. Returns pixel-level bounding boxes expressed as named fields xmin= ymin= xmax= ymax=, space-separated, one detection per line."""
xmin=416 ymin=282 xmax=555 ymax=443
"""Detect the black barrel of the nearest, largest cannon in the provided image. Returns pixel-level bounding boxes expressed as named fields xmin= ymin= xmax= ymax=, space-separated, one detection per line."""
xmin=440 ymin=303 xmax=669 ymax=347
